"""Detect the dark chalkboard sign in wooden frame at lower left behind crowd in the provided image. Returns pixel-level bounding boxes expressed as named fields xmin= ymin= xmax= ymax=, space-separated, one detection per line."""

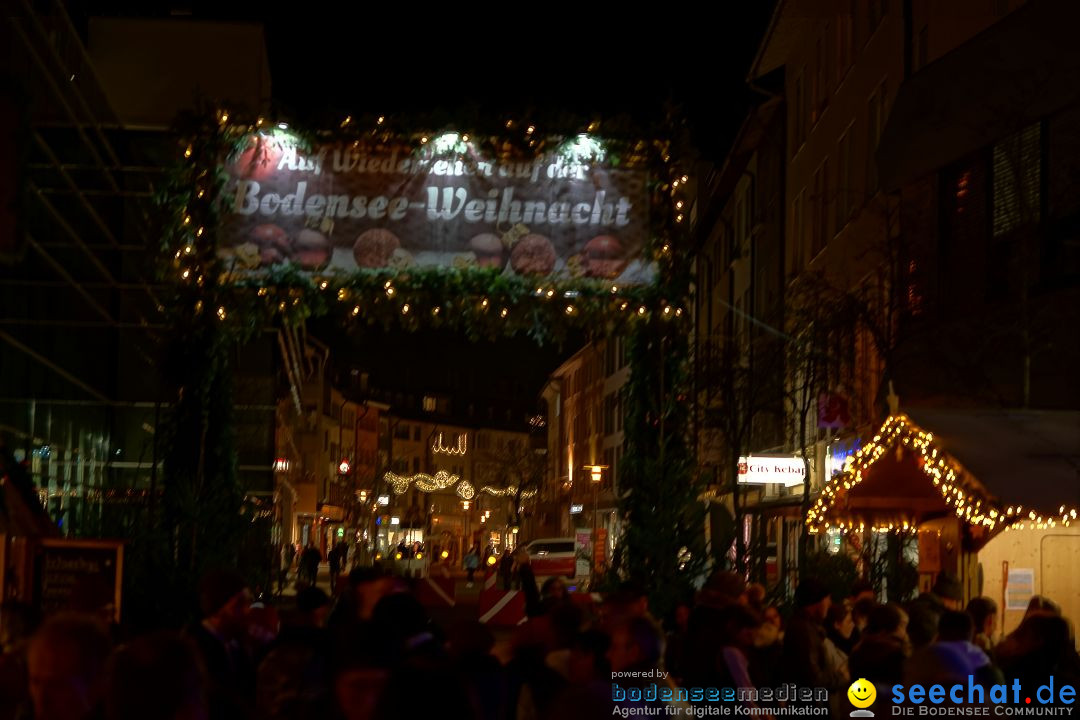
xmin=33 ymin=539 xmax=124 ymax=623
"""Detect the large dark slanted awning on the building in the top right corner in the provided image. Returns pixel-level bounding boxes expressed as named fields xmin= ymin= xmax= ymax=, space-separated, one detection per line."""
xmin=877 ymin=0 xmax=1080 ymax=190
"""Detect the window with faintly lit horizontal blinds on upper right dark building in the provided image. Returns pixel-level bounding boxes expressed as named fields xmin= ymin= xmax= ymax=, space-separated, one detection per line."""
xmin=991 ymin=123 xmax=1042 ymax=237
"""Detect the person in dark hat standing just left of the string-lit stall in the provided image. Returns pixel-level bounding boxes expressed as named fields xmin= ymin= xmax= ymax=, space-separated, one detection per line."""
xmin=784 ymin=578 xmax=835 ymax=688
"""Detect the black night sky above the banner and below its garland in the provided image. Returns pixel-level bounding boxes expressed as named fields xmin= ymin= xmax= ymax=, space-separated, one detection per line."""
xmin=70 ymin=0 xmax=774 ymax=405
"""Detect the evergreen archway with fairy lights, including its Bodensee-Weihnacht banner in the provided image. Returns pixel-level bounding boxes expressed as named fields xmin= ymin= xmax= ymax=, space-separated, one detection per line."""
xmin=152 ymin=110 xmax=705 ymax=611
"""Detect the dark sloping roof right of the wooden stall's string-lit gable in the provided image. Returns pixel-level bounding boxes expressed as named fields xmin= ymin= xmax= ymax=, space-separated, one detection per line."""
xmin=905 ymin=407 xmax=1080 ymax=516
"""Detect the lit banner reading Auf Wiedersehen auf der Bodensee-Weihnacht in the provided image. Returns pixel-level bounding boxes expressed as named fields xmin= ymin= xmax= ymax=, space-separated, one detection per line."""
xmin=211 ymin=132 xmax=652 ymax=284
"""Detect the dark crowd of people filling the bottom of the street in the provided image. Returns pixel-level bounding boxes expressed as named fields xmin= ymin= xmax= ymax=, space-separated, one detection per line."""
xmin=0 ymin=555 xmax=1080 ymax=720
